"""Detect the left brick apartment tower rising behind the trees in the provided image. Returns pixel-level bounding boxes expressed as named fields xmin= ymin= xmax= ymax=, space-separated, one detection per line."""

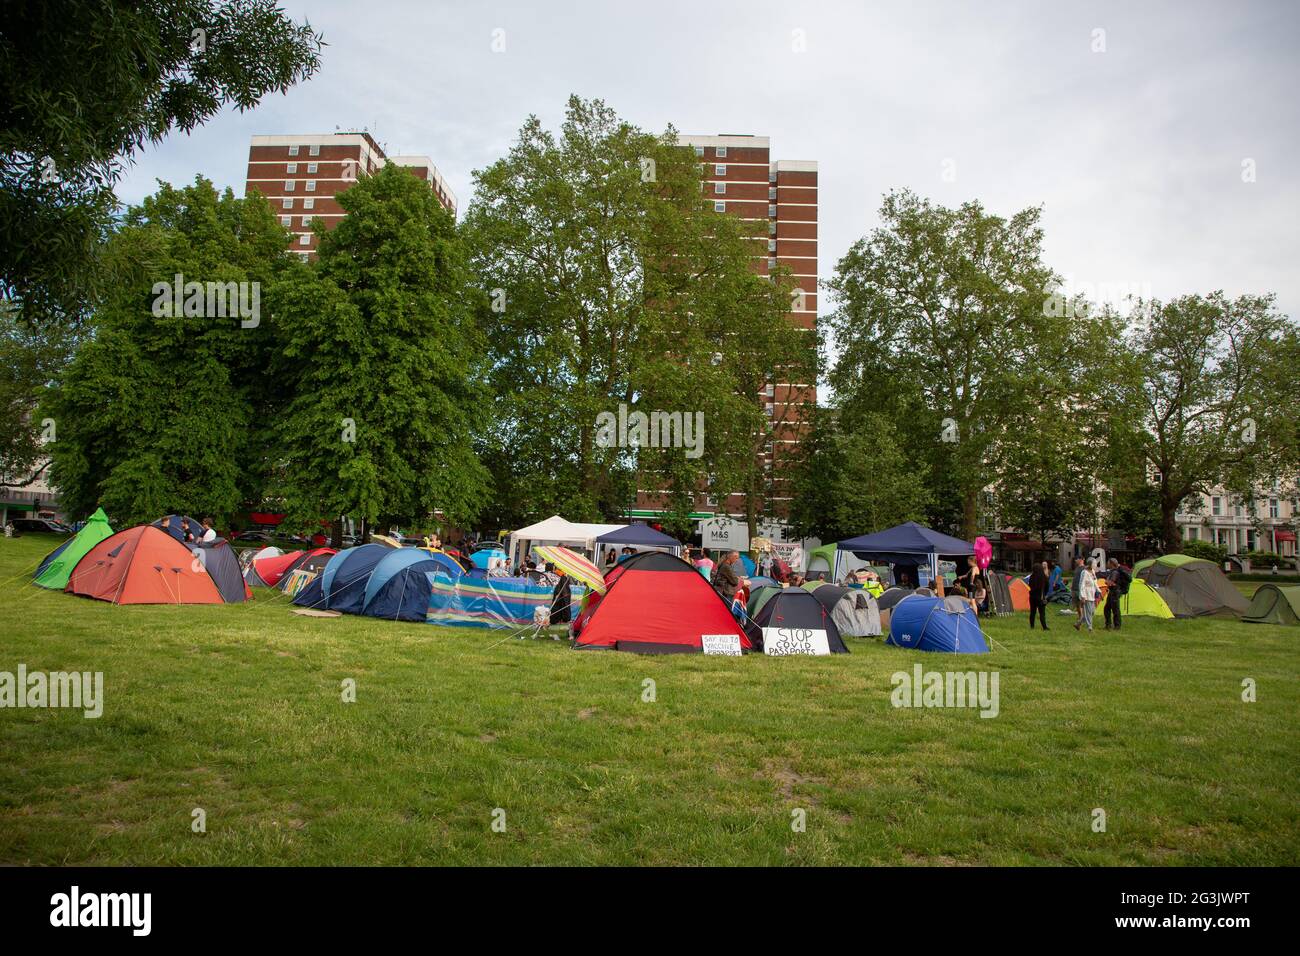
xmin=244 ymin=133 xmax=456 ymax=258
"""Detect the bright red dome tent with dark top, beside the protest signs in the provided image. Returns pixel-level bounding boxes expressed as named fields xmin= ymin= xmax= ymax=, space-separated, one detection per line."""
xmin=573 ymin=551 xmax=754 ymax=654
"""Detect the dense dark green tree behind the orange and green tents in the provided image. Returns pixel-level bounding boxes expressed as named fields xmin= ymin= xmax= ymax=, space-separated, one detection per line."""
xmin=42 ymin=177 xmax=294 ymax=523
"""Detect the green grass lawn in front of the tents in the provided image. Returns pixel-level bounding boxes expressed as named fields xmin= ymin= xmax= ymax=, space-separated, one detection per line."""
xmin=0 ymin=536 xmax=1300 ymax=865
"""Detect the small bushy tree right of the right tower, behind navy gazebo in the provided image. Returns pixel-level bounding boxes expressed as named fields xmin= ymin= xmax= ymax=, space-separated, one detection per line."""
xmin=790 ymin=411 xmax=928 ymax=541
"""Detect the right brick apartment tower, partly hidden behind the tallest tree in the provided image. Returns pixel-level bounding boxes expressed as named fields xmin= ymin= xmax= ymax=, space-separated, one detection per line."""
xmin=632 ymin=135 xmax=818 ymax=538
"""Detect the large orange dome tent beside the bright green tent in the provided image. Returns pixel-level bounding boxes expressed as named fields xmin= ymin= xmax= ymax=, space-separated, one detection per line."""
xmin=66 ymin=524 xmax=224 ymax=604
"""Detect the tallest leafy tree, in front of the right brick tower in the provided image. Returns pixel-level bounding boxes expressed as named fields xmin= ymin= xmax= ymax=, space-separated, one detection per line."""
xmin=465 ymin=96 xmax=789 ymax=528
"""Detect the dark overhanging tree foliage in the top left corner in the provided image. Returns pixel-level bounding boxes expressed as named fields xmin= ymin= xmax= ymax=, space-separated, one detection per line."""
xmin=0 ymin=0 xmax=321 ymax=317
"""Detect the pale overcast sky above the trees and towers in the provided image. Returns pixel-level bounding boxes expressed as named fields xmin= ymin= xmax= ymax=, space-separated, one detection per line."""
xmin=118 ymin=0 xmax=1300 ymax=325
